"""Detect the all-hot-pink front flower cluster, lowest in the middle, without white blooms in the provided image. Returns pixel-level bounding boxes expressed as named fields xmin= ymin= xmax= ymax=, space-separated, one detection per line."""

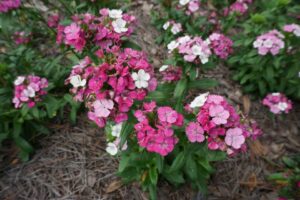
xmin=134 ymin=102 xmax=183 ymax=156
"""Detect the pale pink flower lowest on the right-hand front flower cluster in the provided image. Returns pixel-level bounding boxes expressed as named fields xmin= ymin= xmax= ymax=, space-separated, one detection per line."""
xmin=225 ymin=128 xmax=245 ymax=149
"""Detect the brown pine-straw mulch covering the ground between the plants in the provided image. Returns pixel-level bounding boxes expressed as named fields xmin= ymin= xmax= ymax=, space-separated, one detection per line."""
xmin=0 ymin=1 xmax=300 ymax=200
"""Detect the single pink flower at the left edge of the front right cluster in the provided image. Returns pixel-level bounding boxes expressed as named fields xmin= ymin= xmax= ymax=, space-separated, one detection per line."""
xmin=185 ymin=122 xmax=205 ymax=142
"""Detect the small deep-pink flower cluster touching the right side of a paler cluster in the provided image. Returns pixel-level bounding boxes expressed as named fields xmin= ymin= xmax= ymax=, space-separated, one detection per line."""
xmin=208 ymin=33 xmax=233 ymax=59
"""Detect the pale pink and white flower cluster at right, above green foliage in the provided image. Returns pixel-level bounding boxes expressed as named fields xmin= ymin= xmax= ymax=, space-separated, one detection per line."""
xmin=253 ymin=30 xmax=285 ymax=55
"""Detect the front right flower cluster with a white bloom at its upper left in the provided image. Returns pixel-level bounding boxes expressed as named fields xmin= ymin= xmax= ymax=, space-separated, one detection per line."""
xmin=186 ymin=93 xmax=261 ymax=155
